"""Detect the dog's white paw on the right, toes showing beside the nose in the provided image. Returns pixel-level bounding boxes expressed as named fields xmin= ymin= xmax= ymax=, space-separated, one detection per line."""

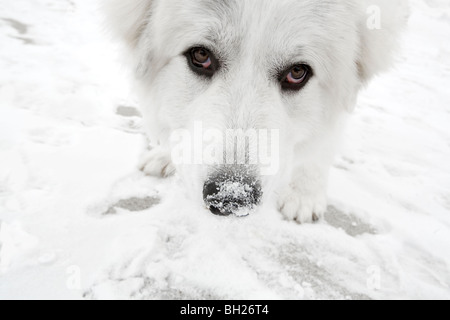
xmin=278 ymin=188 xmax=327 ymax=223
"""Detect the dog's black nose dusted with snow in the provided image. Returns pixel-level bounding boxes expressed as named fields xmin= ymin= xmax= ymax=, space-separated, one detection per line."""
xmin=203 ymin=173 xmax=262 ymax=216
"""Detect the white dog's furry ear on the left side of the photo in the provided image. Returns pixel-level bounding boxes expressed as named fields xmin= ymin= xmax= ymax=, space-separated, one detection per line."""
xmin=103 ymin=0 xmax=152 ymax=49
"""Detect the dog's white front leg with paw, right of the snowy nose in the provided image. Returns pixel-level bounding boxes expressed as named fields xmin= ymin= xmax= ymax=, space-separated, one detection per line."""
xmin=278 ymin=164 xmax=329 ymax=223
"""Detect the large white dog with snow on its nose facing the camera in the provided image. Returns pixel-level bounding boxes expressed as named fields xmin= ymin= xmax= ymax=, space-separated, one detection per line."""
xmin=106 ymin=0 xmax=407 ymax=223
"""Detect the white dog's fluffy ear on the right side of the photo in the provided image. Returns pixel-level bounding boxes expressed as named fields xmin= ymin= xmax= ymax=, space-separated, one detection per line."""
xmin=357 ymin=0 xmax=409 ymax=84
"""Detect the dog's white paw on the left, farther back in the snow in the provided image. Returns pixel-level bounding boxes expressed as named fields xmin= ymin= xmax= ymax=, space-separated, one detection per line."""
xmin=139 ymin=147 xmax=175 ymax=178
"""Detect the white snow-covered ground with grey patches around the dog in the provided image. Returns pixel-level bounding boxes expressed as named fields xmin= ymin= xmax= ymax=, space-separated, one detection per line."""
xmin=0 ymin=0 xmax=450 ymax=299
